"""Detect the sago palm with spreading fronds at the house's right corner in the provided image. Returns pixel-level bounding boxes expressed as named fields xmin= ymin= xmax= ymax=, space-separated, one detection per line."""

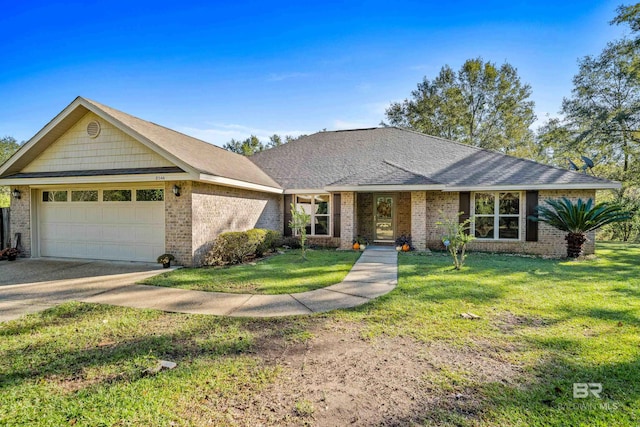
xmin=530 ymin=197 xmax=630 ymax=258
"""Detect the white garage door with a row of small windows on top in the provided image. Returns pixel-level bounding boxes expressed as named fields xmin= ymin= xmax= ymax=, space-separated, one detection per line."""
xmin=38 ymin=188 xmax=164 ymax=262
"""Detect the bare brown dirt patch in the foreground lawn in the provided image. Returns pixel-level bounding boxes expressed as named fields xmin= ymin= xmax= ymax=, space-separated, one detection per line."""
xmin=220 ymin=320 xmax=521 ymax=426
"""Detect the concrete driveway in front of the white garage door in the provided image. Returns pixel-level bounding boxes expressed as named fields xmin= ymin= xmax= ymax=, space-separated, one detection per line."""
xmin=0 ymin=258 xmax=168 ymax=322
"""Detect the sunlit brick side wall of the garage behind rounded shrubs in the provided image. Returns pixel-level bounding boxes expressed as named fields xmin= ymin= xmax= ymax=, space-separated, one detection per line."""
xmin=191 ymin=182 xmax=284 ymax=265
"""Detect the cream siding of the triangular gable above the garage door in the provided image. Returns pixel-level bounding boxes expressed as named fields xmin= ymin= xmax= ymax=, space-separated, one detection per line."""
xmin=23 ymin=113 xmax=174 ymax=172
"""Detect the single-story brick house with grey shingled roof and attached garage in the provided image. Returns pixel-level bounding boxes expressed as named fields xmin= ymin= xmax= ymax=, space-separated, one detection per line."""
xmin=0 ymin=97 xmax=620 ymax=266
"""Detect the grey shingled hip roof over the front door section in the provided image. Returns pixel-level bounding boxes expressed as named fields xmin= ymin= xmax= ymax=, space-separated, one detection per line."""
xmin=250 ymin=127 xmax=619 ymax=190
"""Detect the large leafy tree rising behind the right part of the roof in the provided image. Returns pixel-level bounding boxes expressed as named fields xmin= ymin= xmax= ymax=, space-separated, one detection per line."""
xmin=386 ymin=58 xmax=536 ymax=155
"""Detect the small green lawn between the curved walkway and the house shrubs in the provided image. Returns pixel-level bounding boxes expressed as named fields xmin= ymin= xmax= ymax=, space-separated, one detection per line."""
xmin=144 ymin=250 xmax=359 ymax=294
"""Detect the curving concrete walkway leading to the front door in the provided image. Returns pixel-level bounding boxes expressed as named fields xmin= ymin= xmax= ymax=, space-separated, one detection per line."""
xmin=0 ymin=247 xmax=398 ymax=321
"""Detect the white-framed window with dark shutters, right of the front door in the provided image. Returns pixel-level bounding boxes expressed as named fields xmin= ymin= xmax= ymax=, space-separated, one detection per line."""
xmin=473 ymin=192 xmax=520 ymax=240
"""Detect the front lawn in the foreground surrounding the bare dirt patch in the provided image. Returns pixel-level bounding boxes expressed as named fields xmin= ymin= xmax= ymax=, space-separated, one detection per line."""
xmin=0 ymin=243 xmax=640 ymax=426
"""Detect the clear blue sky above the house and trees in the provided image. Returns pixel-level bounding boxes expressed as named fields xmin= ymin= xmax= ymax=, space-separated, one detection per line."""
xmin=0 ymin=0 xmax=626 ymax=145
